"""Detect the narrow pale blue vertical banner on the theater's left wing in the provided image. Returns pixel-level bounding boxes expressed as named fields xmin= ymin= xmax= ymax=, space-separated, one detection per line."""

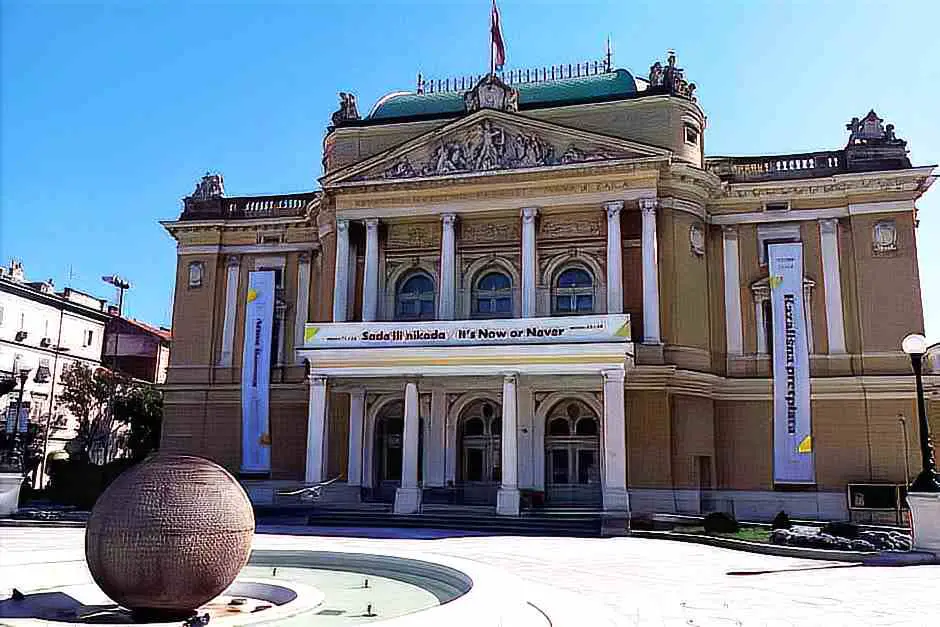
xmin=241 ymin=271 xmax=275 ymax=473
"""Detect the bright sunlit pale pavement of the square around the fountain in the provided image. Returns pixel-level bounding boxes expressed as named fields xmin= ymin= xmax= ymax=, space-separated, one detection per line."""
xmin=0 ymin=527 xmax=940 ymax=627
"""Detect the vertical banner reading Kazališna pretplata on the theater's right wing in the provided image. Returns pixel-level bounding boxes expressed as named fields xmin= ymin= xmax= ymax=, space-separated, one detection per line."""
xmin=767 ymin=242 xmax=816 ymax=483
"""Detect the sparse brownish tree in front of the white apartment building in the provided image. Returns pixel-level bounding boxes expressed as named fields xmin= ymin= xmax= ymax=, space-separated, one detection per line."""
xmin=59 ymin=362 xmax=128 ymax=463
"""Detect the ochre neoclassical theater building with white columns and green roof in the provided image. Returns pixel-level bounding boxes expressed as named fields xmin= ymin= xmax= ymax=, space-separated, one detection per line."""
xmin=163 ymin=50 xmax=933 ymax=519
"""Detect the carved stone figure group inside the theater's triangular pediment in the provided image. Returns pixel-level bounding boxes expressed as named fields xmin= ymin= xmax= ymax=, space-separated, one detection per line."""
xmin=368 ymin=120 xmax=626 ymax=180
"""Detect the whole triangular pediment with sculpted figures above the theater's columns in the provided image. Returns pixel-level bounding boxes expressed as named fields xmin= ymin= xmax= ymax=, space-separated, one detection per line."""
xmin=322 ymin=110 xmax=671 ymax=187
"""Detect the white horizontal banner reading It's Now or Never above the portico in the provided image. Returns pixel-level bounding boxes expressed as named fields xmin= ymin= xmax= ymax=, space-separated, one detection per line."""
xmin=304 ymin=314 xmax=631 ymax=348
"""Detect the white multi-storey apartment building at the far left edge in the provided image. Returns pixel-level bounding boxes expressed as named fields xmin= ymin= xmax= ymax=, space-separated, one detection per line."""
xmin=0 ymin=261 xmax=109 ymax=484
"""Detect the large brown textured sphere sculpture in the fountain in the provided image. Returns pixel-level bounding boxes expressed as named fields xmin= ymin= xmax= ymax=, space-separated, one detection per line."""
xmin=85 ymin=453 xmax=255 ymax=620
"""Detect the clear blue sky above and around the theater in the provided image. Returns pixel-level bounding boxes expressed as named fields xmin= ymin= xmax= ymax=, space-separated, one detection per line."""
xmin=0 ymin=0 xmax=940 ymax=340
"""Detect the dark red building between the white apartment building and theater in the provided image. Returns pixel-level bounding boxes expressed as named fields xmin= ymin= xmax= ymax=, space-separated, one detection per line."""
xmin=102 ymin=316 xmax=172 ymax=383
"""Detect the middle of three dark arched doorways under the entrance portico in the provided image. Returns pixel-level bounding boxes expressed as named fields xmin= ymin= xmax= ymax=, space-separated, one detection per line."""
xmin=457 ymin=399 xmax=502 ymax=505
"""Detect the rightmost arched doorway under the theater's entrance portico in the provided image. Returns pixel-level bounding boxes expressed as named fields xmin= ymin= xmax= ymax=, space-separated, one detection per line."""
xmin=545 ymin=399 xmax=601 ymax=507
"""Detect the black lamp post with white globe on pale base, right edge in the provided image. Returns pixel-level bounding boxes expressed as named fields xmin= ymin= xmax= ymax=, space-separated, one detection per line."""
xmin=901 ymin=333 xmax=940 ymax=554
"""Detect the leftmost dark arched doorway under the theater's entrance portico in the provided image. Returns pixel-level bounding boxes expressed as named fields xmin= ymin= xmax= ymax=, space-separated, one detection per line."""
xmin=372 ymin=401 xmax=424 ymax=503
